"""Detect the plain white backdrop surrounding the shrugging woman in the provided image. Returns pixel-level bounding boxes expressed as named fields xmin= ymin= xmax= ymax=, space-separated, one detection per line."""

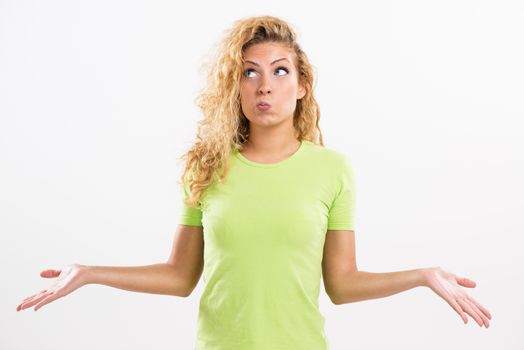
xmin=0 ymin=0 xmax=524 ymax=350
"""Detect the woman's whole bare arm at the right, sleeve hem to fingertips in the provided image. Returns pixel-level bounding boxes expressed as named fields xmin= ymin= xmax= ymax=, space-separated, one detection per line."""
xmin=322 ymin=230 xmax=491 ymax=328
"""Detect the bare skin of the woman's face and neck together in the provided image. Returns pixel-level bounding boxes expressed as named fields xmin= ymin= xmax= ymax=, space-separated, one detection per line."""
xmin=240 ymin=42 xmax=306 ymax=163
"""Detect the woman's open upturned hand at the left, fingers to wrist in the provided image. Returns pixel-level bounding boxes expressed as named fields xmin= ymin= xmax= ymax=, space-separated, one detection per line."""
xmin=16 ymin=264 xmax=86 ymax=311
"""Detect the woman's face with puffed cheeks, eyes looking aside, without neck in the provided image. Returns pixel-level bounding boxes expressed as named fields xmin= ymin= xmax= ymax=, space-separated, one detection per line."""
xmin=240 ymin=43 xmax=306 ymax=127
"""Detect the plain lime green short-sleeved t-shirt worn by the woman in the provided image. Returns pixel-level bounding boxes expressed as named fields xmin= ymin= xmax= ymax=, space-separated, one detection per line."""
xmin=179 ymin=140 xmax=355 ymax=350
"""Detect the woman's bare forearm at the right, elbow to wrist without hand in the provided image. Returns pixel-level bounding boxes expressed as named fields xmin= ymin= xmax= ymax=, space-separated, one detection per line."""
xmin=332 ymin=269 xmax=425 ymax=305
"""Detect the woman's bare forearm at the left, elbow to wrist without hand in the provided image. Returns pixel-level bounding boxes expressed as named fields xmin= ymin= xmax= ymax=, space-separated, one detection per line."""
xmin=84 ymin=263 xmax=189 ymax=297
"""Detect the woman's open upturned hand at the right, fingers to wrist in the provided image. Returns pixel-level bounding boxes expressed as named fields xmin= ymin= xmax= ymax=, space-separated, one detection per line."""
xmin=422 ymin=267 xmax=491 ymax=328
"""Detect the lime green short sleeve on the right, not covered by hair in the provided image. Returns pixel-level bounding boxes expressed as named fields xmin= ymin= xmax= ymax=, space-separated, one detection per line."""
xmin=327 ymin=156 xmax=356 ymax=230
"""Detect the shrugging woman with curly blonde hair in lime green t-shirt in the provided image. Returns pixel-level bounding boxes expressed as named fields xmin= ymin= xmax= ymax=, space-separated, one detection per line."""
xmin=17 ymin=16 xmax=491 ymax=350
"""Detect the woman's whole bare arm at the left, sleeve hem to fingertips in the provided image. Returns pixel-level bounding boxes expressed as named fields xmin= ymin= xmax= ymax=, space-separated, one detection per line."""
xmin=16 ymin=225 xmax=204 ymax=311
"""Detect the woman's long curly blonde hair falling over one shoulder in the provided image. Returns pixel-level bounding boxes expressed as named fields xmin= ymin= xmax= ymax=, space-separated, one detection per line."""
xmin=182 ymin=16 xmax=324 ymax=207
